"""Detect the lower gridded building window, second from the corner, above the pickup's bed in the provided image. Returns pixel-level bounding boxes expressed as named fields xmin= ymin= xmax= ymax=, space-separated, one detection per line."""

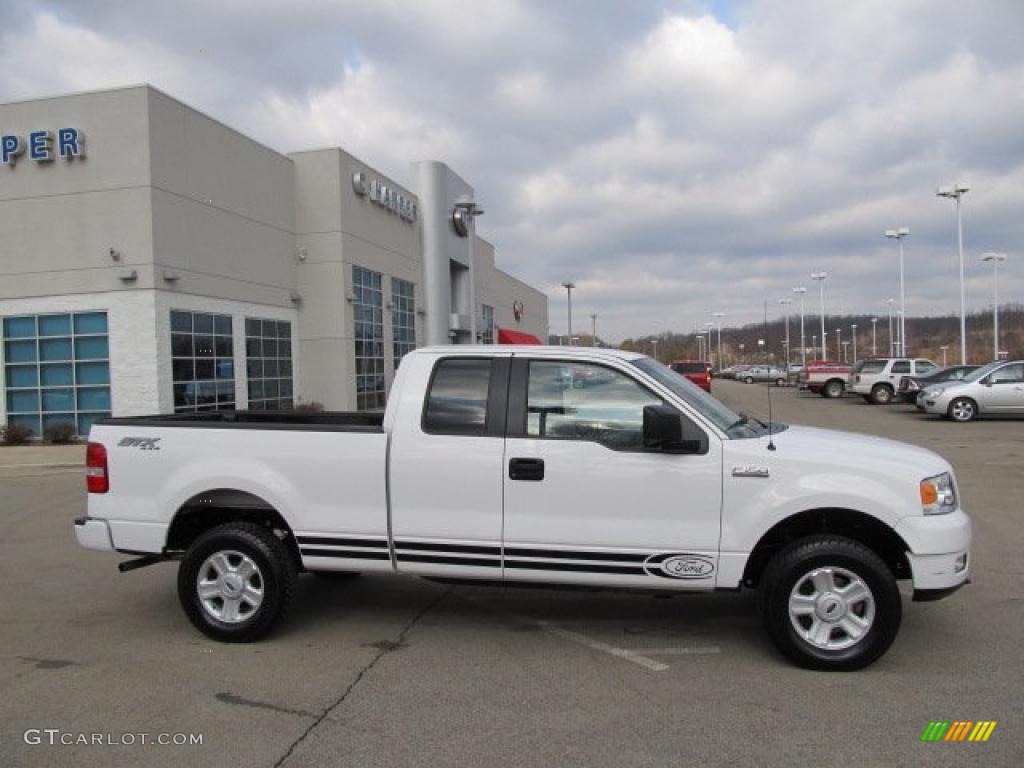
xmin=246 ymin=317 xmax=295 ymax=411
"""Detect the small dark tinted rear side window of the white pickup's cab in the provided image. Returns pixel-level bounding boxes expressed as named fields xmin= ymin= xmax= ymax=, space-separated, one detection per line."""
xmin=423 ymin=358 xmax=492 ymax=435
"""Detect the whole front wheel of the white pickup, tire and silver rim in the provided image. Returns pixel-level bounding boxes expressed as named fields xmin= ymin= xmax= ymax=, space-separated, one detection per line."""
xmin=761 ymin=536 xmax=903 ymax=672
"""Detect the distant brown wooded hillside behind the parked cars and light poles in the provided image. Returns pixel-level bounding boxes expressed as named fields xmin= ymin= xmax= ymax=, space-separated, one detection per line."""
xmin=614 ymin=304 xmax=1024 ymax=366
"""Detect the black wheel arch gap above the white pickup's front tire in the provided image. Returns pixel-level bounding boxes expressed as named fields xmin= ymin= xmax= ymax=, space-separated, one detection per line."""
xmin=742 ymin=508 xmax=912 ymax=587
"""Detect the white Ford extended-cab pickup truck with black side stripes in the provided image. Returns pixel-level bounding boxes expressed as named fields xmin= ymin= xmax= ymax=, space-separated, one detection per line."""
xmin=75 ymin=346 xmax=971 ymax=670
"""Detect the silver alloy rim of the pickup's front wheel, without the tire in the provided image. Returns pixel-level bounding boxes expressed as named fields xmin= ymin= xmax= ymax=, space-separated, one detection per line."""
xmin=790 ymin=567 xmax=874 ymax=650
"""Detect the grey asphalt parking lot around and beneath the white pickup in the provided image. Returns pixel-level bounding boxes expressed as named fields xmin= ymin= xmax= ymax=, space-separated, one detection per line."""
xmin=0 ymin=382 xmax=1024 ymax=768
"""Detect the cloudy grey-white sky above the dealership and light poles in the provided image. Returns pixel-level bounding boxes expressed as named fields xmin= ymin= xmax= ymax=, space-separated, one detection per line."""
xmin=0 ymin=0 xmax=1024 ymax=340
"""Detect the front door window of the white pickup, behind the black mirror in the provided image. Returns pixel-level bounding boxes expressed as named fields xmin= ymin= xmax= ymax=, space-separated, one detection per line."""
xmin=526 ymin=360 xmax=663 ymax=451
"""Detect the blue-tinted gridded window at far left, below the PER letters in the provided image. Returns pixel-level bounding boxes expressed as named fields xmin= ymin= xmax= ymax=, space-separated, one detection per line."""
xmin=3 ymin=312 xmax=111 ymax=436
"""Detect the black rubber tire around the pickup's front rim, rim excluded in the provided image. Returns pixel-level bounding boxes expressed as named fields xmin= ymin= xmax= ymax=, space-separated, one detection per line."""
xmin=760 ymin=535 xmax=903 ymax=672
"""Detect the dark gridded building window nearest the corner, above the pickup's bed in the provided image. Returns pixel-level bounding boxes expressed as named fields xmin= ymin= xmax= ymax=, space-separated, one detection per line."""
xmin=171 ymin=310 xmax=234 ymax=413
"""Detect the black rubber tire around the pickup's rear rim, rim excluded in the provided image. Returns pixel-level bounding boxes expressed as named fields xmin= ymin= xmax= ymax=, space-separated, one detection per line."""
xmin=178 ymin=522 xmax=298 ymax=643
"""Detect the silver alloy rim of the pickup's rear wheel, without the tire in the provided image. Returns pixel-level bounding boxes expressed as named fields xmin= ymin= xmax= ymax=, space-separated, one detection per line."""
xmin=196 ymin=550 xmax=263 ymax=624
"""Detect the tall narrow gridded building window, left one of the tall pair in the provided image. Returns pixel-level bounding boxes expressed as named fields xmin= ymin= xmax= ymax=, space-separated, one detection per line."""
xmin=352 ymin=266 xmax=387 ymax=411
